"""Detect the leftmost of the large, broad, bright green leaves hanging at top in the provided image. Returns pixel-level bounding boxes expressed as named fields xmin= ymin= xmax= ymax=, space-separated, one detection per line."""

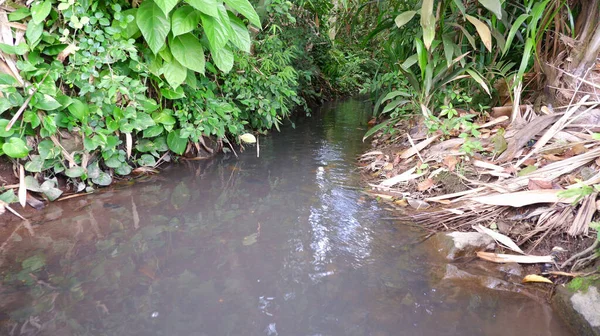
xmin=136 ymin=0 xmax=171 ymax=54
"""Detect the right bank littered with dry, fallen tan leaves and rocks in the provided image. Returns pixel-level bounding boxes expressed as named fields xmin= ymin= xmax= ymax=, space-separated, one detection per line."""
xmin=359 ymin=104 xmax=600 ymax=335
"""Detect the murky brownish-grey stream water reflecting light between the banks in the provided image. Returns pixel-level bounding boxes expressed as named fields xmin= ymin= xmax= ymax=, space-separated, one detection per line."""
xmin=0 ymin=101 xmax=569 ymax=336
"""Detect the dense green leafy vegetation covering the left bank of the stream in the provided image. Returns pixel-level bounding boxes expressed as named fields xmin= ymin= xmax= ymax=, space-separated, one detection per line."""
xmin=0 ymin=0 xmax=372 ymax=202
